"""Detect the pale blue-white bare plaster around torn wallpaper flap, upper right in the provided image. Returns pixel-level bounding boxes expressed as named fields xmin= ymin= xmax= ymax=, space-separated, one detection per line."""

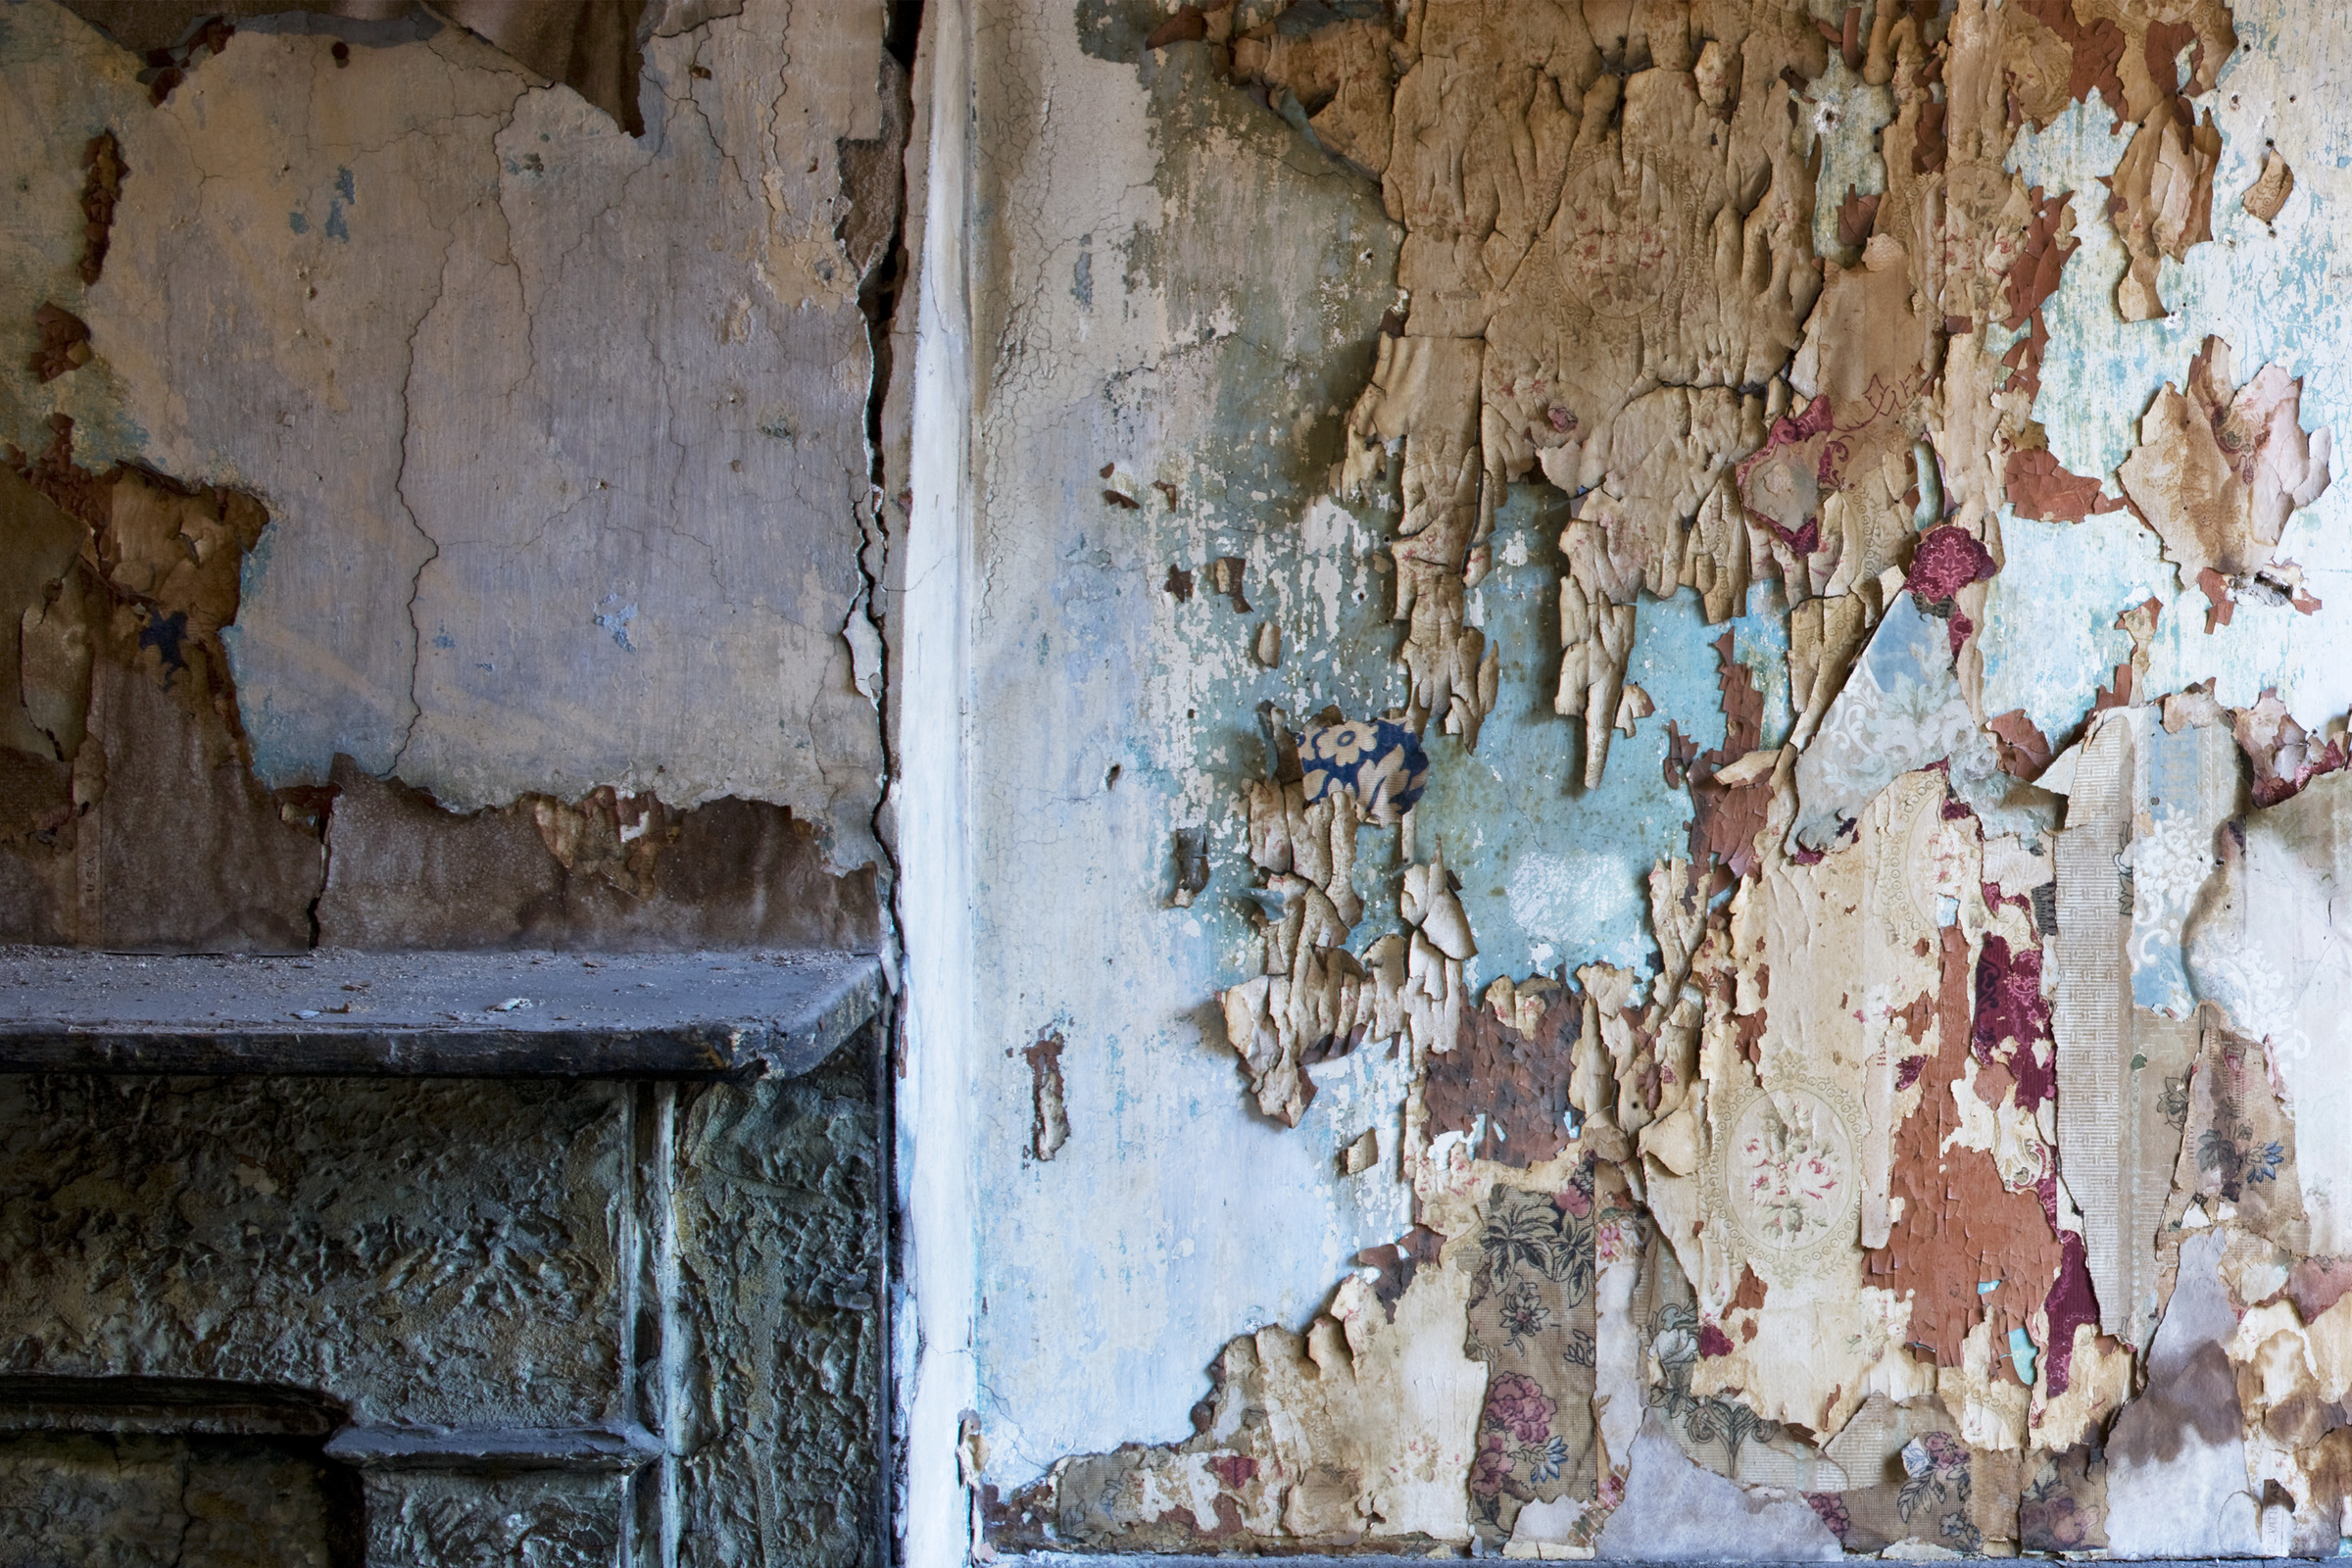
xmin=1985 ymin=0 xmax=2352 ymax=738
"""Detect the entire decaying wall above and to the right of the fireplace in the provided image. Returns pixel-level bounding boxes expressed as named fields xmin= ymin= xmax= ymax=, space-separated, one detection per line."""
xmin=23 ymin=0 xmax=2352 ymax=1561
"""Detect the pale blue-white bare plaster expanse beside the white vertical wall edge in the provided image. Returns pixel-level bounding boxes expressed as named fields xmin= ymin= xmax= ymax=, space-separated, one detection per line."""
xmin=971 ymin=42 xmax=1409 ymax=1486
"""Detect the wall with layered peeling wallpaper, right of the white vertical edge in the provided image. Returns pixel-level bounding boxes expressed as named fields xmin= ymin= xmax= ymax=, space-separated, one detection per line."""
xmin=907 ymin=0 xmax=2352 ymax=1561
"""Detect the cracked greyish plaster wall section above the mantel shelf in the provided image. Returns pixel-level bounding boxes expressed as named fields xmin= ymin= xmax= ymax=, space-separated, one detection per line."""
xmin=0 ymin=0 xmax=906 ymax=948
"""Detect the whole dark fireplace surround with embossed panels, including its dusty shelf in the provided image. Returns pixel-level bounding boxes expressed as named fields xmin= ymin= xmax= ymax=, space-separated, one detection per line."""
xmin=0 ymin=948 xmax=887 ymax=1568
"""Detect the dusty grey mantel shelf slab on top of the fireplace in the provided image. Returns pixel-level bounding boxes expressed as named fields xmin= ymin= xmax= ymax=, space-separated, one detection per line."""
xmin=0 ymin=948 xmax=884 ymax=1079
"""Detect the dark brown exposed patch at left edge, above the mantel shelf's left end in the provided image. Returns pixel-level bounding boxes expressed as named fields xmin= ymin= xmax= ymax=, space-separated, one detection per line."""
xmin=0 ymin=416 xmax=324 ymax=950
